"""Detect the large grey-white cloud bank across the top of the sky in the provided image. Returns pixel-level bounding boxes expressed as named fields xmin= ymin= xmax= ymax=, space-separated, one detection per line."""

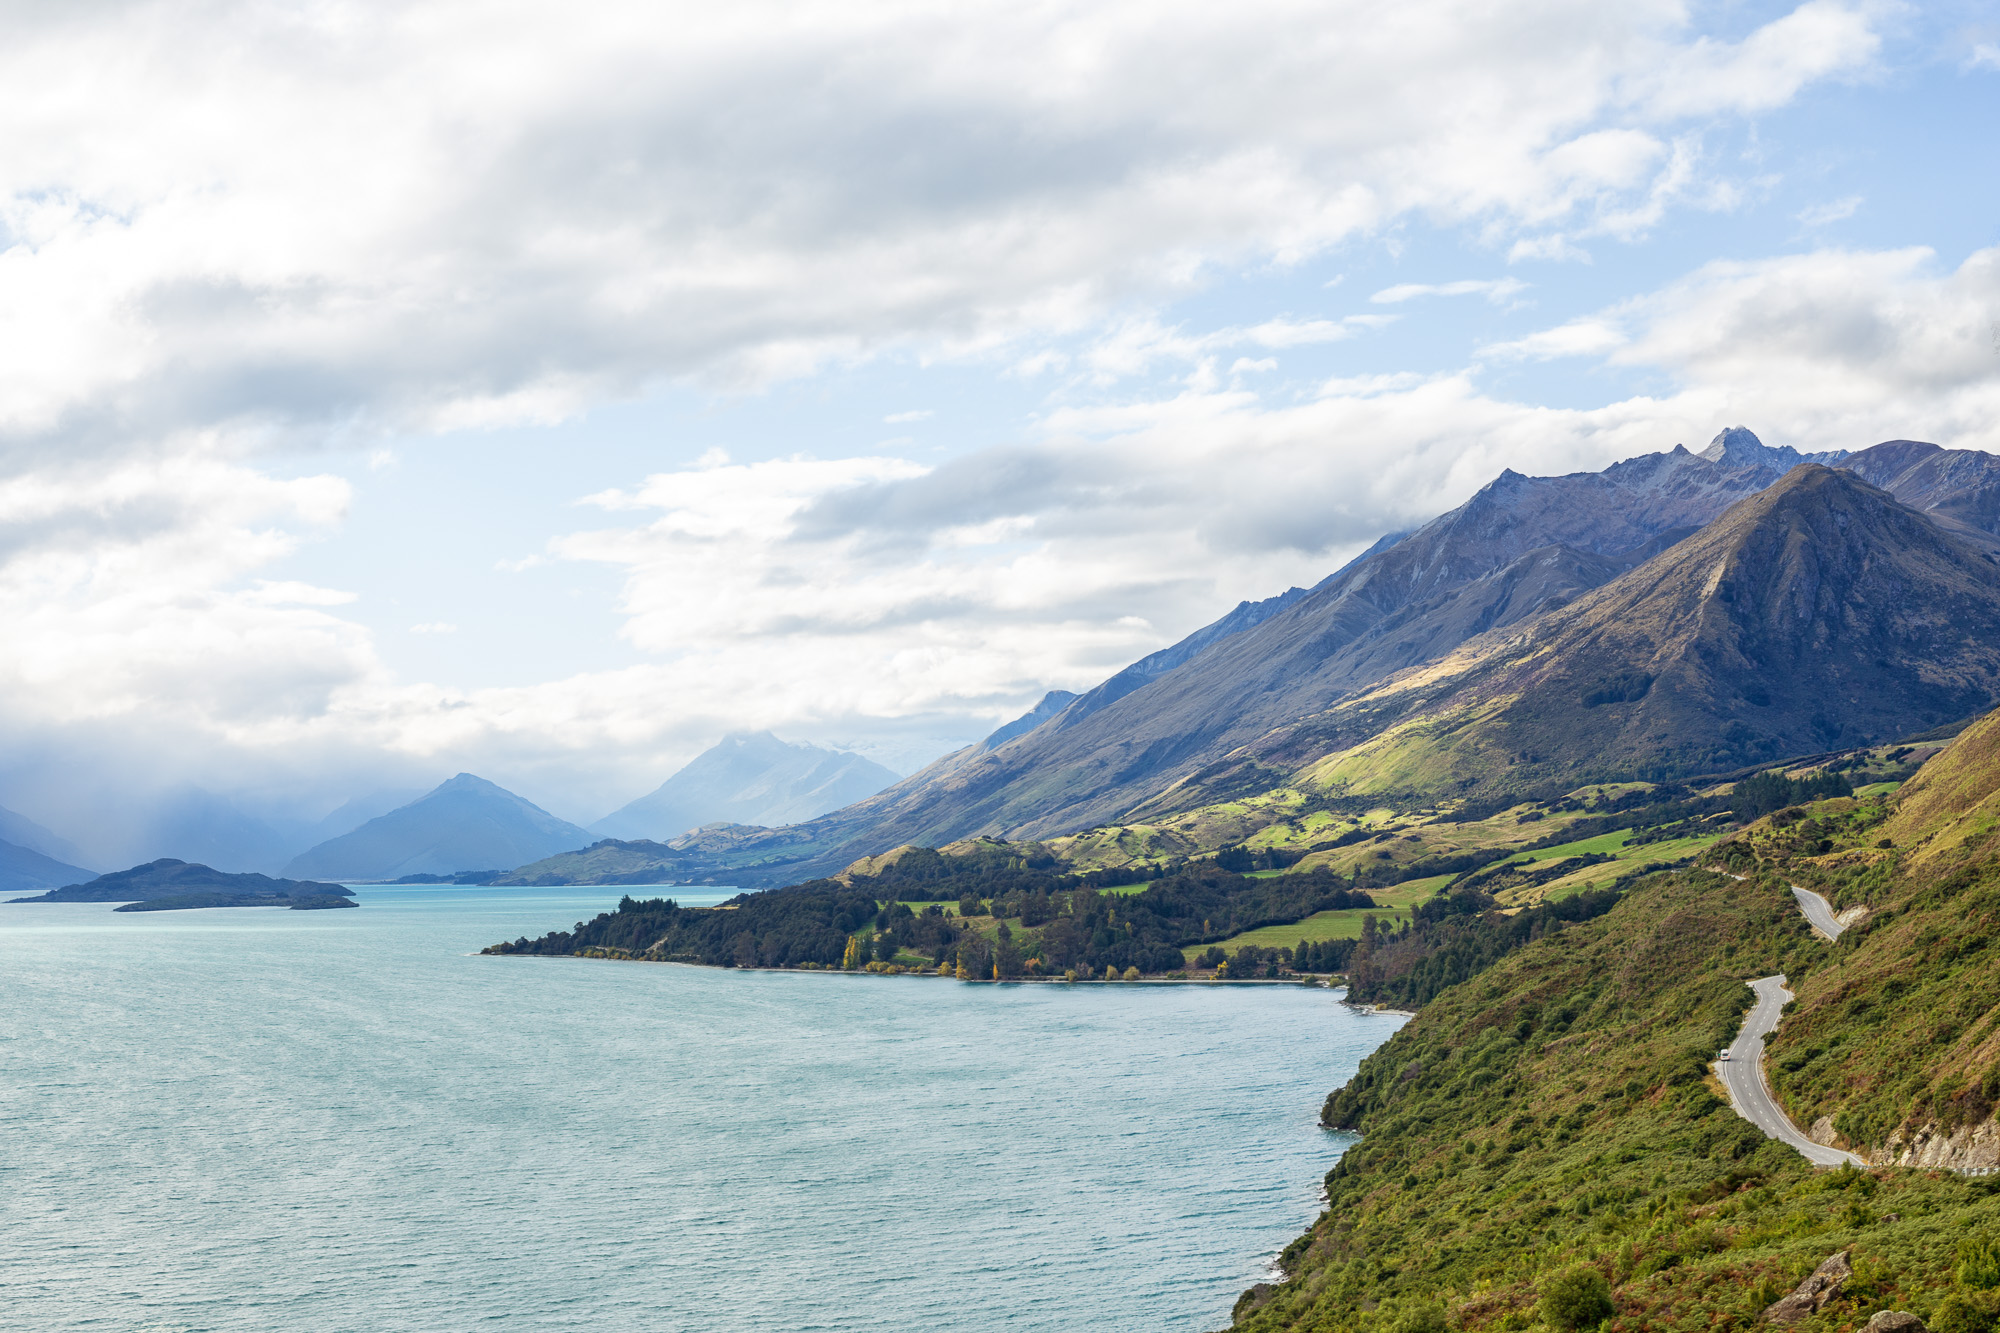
xmin=0 ymin=0 xmax=1876 ymax=450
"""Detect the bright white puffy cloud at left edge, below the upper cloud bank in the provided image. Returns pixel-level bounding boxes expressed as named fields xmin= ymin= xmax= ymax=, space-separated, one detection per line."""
xmin=0 ymin=456 xmax=376 ymax=741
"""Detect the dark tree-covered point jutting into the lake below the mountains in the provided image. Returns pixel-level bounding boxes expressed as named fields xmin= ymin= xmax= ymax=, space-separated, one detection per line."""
xmin=488 ymin=849 xmax=1374 ymax=979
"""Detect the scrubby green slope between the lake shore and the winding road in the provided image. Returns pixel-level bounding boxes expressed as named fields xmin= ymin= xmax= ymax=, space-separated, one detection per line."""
xmin=1236 ymin=871 xmax=2000 ymax=1329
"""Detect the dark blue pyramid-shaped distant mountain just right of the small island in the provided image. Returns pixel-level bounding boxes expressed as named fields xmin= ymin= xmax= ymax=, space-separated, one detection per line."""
xmin=284 ymin=773 xmax=592 ymax=881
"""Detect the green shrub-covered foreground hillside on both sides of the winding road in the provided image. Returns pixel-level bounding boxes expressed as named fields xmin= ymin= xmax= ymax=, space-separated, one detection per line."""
xmin=1236 ymin=717 xmax=2000 ymax=1333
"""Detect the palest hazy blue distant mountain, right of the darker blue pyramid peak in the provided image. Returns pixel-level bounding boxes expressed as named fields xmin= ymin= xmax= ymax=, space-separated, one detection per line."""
xmin=590 ymin=731 xmax=896 ymax=839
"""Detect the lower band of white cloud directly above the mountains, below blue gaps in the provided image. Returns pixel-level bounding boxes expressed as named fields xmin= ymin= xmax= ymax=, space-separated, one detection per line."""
xmin=0 ymin=250 xmax=2000 ymax=815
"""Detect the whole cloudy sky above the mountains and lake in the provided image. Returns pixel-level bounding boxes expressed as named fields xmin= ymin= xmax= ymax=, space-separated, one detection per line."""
xmin=0 ymin=0 xmax=2000 ymax=841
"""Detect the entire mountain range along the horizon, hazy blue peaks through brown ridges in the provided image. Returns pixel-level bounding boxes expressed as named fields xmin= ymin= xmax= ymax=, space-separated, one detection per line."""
xmin=19 ymin=426 xmax=2000 ymax=889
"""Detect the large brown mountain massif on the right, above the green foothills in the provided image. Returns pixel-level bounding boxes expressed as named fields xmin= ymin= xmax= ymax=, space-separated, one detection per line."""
xmin=656 ymin=426 xmax=2000 ymax=883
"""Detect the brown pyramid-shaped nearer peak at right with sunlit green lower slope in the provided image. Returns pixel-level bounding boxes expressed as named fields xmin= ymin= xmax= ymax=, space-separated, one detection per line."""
xmin=1192 ymin=466 xmax=2000 ymax=809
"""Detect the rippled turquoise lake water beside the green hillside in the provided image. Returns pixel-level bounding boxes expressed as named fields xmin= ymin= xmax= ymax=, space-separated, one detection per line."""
xmin=0 ymin=887 xmax=1400 ymax=1333
